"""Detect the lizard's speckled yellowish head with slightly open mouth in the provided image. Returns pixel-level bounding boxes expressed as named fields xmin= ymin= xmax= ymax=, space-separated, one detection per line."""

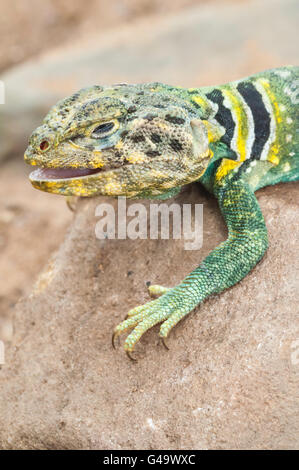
xmin=25 ymin=83 xmax=211 ymax=197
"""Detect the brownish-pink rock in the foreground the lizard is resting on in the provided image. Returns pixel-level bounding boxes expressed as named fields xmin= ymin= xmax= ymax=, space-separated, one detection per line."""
xmin=0 ymin=183 xmax=299 ymax=449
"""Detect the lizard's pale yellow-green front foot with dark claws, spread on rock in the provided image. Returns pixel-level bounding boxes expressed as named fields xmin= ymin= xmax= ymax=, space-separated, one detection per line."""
xmin=112 ymin=286 xmax=197 ymax=358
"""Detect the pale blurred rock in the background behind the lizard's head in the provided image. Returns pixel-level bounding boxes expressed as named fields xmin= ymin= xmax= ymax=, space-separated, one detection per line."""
xmin=0 ymin=0 xmax=299 ymax=160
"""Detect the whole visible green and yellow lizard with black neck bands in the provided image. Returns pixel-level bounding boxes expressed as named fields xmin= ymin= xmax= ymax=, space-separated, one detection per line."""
xmin=25 ymin=66 xmax=299 ymax=357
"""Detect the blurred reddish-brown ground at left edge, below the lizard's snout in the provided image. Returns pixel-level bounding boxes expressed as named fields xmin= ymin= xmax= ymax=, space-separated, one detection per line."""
xmin=0 ymin=159 xmax=72 ymax=343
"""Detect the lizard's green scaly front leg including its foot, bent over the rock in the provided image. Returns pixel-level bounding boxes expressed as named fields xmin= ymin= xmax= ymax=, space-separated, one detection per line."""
xmin=113 ymin=179 xmax=268 ymax=353
